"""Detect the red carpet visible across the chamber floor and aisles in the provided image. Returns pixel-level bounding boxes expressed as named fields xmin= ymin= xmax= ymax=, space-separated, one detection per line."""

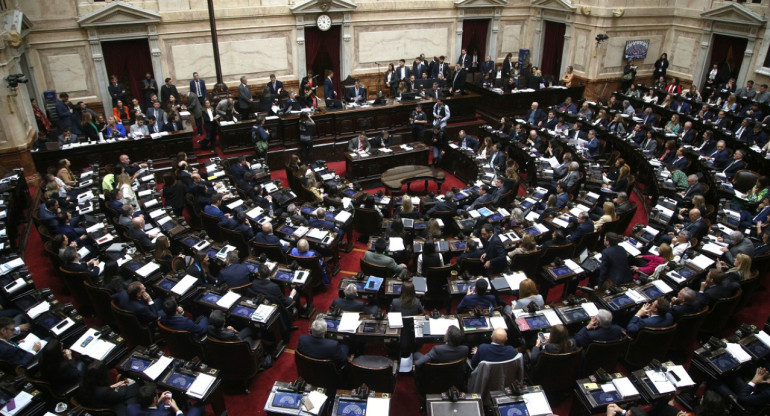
xmin=25 ymin=158 xmax=770 ymax=416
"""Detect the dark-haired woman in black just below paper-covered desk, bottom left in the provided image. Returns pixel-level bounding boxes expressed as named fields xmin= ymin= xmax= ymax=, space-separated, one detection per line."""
xmin=75 ymin=360 xmax=140 ymax=416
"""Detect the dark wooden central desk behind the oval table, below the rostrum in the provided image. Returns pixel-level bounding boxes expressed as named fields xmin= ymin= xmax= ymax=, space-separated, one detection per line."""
xmin=345 ymin=143 xmax=430 ymax=184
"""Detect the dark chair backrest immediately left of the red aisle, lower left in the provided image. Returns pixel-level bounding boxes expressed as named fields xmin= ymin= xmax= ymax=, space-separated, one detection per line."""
xmin=204 ymin=337 xmax=262 ymax=386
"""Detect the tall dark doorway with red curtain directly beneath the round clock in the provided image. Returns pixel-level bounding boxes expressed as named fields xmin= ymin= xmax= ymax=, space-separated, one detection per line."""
xmin=305 ymin=25 xmax=342 ymax=98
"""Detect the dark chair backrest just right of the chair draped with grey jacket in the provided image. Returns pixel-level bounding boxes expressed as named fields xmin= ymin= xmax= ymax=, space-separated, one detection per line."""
xmin=530 ymin=348 xmax=583 ymax=393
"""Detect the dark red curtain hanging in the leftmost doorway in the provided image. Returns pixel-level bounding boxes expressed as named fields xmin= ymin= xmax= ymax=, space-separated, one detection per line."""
xmin=102 ymin=39 xmax=155 ymax=105
